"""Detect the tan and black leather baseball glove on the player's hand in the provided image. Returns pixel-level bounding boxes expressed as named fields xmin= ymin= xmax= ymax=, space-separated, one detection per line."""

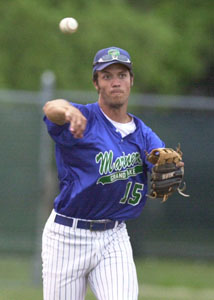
xmin=147 ymin=147 xmax=189 ymax=202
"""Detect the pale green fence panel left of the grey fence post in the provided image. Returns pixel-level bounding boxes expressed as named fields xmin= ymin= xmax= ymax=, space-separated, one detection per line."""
xmin=0 ymin=99 xmax=40 ymax=251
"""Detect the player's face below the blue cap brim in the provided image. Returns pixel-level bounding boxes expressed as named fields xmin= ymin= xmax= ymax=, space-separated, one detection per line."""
xmin=94 ymin=64 xmax=133 ymax=109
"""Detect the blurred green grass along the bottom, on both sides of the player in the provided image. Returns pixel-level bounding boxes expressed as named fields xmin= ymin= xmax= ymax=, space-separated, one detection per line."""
xmin=0 ymin=256 xmax=214 ymax=300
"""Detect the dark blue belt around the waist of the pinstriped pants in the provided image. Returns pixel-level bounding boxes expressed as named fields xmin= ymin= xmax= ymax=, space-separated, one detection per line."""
xmin=54 ymin=215 xmax=122 ymax=231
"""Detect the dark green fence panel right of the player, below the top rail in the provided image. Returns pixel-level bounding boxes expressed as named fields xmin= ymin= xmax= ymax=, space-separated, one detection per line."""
xmin=127 ymin=107 xmax=214 ymax=258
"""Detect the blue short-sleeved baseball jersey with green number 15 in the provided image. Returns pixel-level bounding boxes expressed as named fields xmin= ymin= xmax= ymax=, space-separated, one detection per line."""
xmin=44 ymin=103 xmax=165 ymax=221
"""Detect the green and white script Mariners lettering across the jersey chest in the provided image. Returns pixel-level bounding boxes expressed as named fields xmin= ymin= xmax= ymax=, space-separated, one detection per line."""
xmin=95 ymin=150 xmax=142 ymax=175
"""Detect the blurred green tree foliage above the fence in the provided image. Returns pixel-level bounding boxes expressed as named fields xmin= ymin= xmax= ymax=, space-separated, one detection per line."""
xmin=0 ymin=0 xmax=214 ymax=93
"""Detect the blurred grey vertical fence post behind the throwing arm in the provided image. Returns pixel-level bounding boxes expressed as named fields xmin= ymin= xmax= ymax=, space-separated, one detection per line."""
xmin=33 ymin=71 xmax=56 ymax=285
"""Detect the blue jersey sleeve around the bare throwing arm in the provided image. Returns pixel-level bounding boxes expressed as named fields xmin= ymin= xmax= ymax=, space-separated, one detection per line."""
xmin=43 ymin=102 xmax=89 ymax=146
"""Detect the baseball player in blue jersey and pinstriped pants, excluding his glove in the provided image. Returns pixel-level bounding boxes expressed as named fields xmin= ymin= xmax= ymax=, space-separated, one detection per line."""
xmin=42 ymin=47 xmax=164 ymax=300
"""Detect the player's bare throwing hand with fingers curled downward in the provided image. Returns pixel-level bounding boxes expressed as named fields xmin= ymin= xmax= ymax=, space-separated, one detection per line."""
xmin=65 ymin=107 xmax=87 ymax=139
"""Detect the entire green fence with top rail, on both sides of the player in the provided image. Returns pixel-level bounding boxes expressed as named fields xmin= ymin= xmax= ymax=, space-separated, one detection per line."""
xmin=0 ymin=80 xmax=214 ymax=259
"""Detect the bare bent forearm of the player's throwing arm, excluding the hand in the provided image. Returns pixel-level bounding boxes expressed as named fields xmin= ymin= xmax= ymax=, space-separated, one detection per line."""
xmin=43 ymin=99 xmax=72 ymax=125
